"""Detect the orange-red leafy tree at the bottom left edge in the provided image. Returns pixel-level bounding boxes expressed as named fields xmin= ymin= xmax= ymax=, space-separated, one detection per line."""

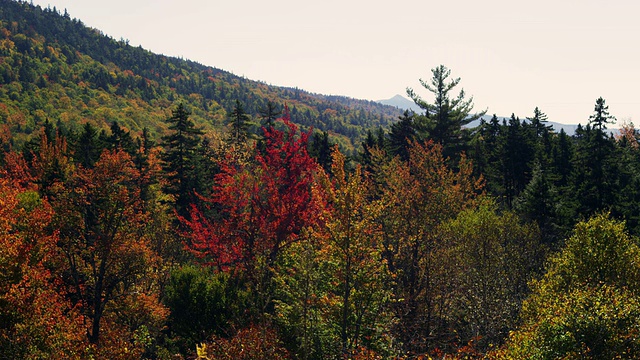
xmin=0 ymin=176 xmax=89 ymax=359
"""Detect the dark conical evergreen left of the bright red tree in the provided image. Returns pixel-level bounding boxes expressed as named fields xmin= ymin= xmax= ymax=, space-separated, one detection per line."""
xmin=162 ymin=103 xmax=203 ymax=216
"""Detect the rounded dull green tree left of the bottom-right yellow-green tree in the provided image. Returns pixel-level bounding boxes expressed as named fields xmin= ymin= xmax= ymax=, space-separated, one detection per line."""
xmin=439 ymin=200 xmax=543 ymax=350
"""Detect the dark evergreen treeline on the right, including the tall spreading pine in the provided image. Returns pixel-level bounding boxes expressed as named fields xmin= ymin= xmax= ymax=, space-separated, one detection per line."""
xmin=376 ymin=66 xmax=640 ymax=248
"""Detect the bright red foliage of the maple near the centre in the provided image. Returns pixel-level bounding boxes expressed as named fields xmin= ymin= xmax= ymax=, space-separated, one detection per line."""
xmin=185 ymin=111 xmax=321 ymax=269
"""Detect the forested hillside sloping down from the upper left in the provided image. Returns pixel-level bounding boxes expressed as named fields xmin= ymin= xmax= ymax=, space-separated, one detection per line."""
xmin=0 ymin=0 xmax=401 ymax=150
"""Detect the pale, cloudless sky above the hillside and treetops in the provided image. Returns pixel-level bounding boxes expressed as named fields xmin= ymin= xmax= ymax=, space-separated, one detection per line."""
xmin=28 ymin=0 xmax=640 ymax=124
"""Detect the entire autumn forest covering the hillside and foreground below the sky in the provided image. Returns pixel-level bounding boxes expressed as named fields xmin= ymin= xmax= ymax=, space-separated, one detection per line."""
xmin=0 ymin=0 xmax=640 ymax=359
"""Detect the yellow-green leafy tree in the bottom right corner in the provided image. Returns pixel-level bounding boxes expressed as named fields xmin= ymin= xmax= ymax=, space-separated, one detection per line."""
xmin=493 ymin=214 xmax=640 ymax=359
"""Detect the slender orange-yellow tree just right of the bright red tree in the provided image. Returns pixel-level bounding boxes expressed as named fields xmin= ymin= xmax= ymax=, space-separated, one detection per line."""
xmin=326 ymin=148 xmax=391 ymax=357
